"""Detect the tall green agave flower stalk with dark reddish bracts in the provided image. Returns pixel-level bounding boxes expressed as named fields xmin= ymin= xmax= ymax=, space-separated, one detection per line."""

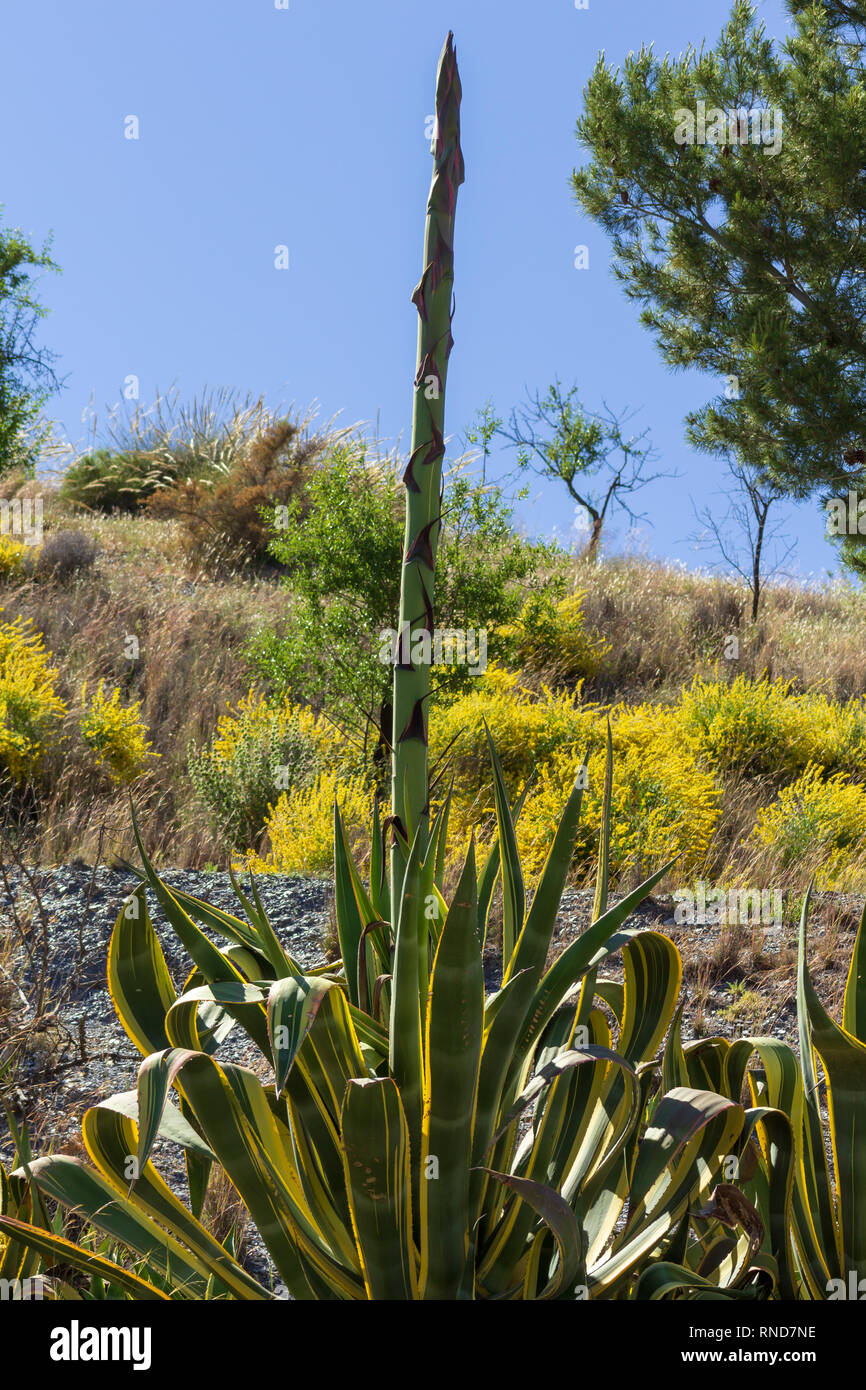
xmin=391 ymin=33 xmax=463 ymax=920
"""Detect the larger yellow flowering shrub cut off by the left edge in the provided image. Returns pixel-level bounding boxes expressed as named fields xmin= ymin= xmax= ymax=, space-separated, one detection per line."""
xmin=0 ymin=609 xmax=67 ymax=783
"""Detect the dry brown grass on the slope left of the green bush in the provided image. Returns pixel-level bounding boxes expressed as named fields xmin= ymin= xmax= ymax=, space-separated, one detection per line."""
xmin=0 ymin=483 xmax=286 ymax=867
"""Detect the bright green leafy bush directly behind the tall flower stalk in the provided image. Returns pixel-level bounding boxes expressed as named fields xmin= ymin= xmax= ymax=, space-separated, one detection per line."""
xmin=250 ymin=439 xmax=564 ymax=767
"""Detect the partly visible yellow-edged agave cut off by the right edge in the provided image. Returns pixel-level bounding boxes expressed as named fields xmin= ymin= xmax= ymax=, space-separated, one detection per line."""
xmin=656 ymin=892 xmax=866 ymax=1300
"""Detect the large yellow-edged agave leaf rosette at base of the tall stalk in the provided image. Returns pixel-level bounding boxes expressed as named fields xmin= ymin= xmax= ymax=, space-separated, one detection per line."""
xmin=0 ymin=722 xmax=762 ymax=1300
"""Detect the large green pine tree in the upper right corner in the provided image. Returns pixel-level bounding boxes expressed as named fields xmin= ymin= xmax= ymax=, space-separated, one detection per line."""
xmin=573 ymin=0 xmax=866 ymax=530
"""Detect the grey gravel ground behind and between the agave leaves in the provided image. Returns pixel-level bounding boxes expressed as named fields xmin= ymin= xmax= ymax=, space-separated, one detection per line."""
xmin=0 ymin=866 xmax=863 ymax=1279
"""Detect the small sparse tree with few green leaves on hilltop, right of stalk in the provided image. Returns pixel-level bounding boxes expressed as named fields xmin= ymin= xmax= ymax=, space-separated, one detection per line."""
xmin=498 ymin=381 xmax=674 ymax=560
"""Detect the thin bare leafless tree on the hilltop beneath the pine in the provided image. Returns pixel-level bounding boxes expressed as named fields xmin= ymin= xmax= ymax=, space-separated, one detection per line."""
xmin=689 ymin=457 xmax=794 ymax=623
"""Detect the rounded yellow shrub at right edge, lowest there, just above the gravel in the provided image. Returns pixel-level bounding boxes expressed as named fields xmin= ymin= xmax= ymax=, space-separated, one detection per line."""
xmin=752 ymin=763 xmax=866 ymax=890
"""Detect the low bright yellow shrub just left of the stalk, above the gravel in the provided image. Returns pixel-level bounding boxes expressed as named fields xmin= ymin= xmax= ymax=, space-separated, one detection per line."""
xmin=246 ymin=769 xmax=373 ymax=874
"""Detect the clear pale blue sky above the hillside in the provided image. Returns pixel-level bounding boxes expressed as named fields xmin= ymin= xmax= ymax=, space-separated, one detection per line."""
xmin=0 ymin=0 xmax=835 ymax=578
